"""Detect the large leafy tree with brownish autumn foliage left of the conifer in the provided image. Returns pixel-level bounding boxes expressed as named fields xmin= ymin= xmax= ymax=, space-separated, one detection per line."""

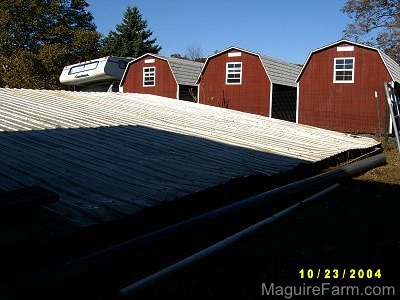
xmin=0 ymin=0 xmax=100 ymax=89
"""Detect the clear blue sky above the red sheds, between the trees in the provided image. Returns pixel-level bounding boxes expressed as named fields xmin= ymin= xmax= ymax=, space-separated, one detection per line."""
xmin=87 ymin=0 xmax=350 ymax=63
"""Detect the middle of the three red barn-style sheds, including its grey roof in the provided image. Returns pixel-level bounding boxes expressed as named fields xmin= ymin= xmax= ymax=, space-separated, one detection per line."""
xmin=197 ymin=47 xmax=301 ymax=122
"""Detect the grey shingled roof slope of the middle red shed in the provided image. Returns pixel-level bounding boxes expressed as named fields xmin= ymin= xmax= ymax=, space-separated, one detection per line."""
xmin=260 ymin=55 xmax=301 ymax=87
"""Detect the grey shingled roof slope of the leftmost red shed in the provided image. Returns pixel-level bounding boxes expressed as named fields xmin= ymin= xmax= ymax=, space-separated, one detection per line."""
xmin=165 ymin=57 xmax=204 ymax=85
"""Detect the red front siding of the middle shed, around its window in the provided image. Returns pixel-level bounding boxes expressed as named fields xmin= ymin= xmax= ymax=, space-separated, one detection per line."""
xmin=199 ymin=50 xmax=271 ymax=116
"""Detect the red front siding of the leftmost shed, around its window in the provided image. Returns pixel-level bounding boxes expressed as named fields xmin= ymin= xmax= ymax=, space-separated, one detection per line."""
xmin=122 ymin=55 xmax=178 ymax=98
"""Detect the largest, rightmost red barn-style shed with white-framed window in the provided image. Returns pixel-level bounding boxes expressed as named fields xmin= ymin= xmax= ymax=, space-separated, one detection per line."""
xmin=296 ymin=40 xmax=400 ymax=134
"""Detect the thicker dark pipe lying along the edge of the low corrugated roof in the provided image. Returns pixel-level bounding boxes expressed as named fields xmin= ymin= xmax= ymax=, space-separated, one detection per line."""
xmin=62 ymin=153 xmax=386 ymax=272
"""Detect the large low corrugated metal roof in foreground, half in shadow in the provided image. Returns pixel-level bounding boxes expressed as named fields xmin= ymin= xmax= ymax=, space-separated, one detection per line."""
xmin=0 ymin=89 xmax=377 ymax=226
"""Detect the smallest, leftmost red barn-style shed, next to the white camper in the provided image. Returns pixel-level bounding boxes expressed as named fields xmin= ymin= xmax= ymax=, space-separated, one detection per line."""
xmin=120 ymin=54 xmax=203 ymax=102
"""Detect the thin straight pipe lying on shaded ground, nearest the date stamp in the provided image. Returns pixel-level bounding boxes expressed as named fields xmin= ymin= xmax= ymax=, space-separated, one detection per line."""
xmin=119 ymin=183 xmax=340 ymax=296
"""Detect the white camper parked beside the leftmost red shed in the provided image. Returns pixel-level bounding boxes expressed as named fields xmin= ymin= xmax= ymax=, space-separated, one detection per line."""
xmin=60 ymin=56 xmax=133 ymax=92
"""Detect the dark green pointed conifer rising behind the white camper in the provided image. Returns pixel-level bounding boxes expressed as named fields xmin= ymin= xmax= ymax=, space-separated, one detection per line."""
xmin=101 ymin=6 xmax=161 ymax=57
